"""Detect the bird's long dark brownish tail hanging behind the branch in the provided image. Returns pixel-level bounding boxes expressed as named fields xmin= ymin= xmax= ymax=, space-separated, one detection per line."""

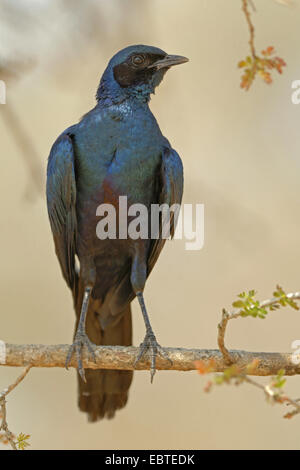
xmin=75 ymin=280 xmax=133 ymax=421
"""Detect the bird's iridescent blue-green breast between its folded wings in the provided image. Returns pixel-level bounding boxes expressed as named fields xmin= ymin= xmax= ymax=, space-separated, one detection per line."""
xmin=74 ymin=102 xmax=168 ymax=253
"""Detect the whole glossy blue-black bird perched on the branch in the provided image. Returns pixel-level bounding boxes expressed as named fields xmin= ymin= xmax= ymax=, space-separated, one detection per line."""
xmin=47 ymin=45 xmax=188 ymax=421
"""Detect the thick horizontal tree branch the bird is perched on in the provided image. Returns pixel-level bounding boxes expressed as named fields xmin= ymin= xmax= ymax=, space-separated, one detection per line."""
xmin=0 ymin=342 xmax=300 ymax=376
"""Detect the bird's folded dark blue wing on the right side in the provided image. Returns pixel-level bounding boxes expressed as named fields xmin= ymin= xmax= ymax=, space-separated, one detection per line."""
xmin=148 ymin=147 xmax=183 ymax=274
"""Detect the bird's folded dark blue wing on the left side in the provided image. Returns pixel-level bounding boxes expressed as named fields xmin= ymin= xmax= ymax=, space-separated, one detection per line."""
xmin=47 ymin=134 xmax=77 ymax=289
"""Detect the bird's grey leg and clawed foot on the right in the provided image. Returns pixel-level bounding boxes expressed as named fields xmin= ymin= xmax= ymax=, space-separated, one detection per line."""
xmin=134 ymin=292 xmax=172 ymax=383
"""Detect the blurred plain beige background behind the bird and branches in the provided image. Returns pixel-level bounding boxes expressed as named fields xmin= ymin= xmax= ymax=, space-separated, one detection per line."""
xmin=0 ymin=0 xmax=300 ymax=449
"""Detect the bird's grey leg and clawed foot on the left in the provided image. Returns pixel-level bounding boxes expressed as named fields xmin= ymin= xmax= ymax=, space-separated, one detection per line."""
xmin=66 ymin=286 xmax=96 ymax=382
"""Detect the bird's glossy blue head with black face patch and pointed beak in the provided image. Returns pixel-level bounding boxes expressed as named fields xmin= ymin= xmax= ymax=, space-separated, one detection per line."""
xmin=96 ymin=45 xmax=188 ymax=104
